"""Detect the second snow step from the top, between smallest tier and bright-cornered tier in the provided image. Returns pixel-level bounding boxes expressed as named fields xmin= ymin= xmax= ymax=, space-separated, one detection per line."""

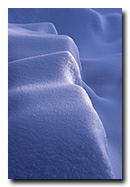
xmin=8 ymin=32 xmax=82 ymax=70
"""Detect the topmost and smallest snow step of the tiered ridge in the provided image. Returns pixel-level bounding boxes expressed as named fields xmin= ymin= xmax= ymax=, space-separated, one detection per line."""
xmin=8 ymin=22 xmax=58 ymax=35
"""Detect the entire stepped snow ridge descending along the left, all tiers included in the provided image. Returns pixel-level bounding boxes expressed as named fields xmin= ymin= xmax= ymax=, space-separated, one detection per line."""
xmin=8 ymin=18 xmax=117 ymax=179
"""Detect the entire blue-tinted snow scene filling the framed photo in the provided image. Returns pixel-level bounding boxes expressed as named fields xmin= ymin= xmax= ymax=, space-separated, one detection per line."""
xmin=8 ymin=9 xmax=122 ymax=179
